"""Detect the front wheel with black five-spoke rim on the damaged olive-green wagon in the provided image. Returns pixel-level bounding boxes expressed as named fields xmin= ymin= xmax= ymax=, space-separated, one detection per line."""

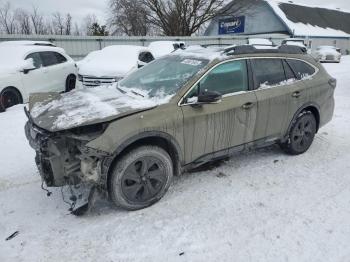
xmin=108 ymin=146 xmax=174 ymax=210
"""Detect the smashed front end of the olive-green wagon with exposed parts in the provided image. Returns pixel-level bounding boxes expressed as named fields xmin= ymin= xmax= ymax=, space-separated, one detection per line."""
xmin=25 ymin=110 xmax=112 ymax=213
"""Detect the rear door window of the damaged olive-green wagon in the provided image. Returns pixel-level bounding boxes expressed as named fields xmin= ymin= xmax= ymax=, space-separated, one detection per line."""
xmin=251 ymin=58 xmax=286 ymax=88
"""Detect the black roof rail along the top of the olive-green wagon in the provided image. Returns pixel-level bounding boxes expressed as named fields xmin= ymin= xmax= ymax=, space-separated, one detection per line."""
xmin=223 ymin=45 xmax=307 ymax=55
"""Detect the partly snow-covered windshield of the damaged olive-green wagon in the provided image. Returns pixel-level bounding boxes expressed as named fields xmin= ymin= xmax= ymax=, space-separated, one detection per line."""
xmin=119 ymin=55 xmax=209 ymax=97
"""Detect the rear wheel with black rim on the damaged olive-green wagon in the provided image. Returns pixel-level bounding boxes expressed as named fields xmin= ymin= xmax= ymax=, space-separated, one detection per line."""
xmin=281 ymin=111 xmax=317 ymax=155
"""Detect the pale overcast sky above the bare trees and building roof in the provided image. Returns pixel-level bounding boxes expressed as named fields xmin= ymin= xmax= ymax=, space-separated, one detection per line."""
xmin=6 ymin=0 xmax=350 ymax=23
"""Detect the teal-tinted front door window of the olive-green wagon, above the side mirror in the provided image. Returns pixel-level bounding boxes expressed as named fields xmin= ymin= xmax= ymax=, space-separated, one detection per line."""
xmin=200 ymin=60 xmax=248 ymax=95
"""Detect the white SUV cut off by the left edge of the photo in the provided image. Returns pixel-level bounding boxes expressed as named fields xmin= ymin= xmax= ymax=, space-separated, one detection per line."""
xmin=0 ymin=44 xmax=77 ymax=111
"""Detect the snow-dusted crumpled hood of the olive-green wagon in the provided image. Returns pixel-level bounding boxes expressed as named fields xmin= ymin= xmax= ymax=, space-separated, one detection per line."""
xmin=30 ymin=85 xmax=167 ymax=132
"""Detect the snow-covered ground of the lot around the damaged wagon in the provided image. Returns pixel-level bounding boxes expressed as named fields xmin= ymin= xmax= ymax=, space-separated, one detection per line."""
xmin=0 ymin=57 xmax=350 ymax=262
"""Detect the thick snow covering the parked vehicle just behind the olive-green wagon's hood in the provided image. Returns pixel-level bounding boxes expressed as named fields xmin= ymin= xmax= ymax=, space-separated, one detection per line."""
xmin=78 ymin=45 xmax=150 ymax=77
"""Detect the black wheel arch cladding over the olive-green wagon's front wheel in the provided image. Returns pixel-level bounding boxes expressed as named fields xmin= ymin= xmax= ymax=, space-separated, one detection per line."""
xmin=108 ymin=131 xmax=183 ymax=179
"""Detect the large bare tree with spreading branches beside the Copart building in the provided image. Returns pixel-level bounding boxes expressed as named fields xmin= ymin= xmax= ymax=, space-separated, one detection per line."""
xmin=142 ymin=0 xmax=259 ymax=36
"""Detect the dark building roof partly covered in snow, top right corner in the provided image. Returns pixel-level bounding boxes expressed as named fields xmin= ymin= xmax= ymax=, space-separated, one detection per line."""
xmin=266 ymin=0 xmax=350 ymax=37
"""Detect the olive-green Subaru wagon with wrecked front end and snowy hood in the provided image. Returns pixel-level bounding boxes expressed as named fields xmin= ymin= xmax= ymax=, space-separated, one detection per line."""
xmin=25 ymin=45 xmax=336 ymax=213
